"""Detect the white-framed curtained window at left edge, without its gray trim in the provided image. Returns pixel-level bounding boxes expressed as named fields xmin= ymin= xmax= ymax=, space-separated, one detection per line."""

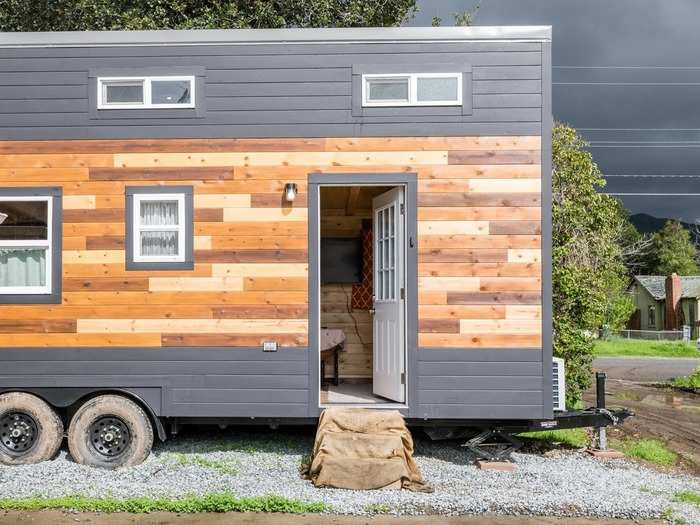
xmin=0 ymin=196 xmax=53 ymax=295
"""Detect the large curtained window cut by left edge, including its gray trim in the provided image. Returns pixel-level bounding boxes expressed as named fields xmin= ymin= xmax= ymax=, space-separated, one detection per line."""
xmin=0 ymin=188 xmax=61 ymax=304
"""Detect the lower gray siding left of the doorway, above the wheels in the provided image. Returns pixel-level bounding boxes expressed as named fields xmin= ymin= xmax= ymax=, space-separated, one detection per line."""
xmin=0 ymin=348 xmax=309 ymax=417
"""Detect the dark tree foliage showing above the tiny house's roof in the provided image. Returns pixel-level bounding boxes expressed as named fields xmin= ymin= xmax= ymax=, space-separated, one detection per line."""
xmin=0 ymin=0 xmax=416 ymax=31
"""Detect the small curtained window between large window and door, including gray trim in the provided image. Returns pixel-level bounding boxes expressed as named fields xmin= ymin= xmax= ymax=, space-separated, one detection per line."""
xmin=127 ymin=187 xmax=193 ymax=270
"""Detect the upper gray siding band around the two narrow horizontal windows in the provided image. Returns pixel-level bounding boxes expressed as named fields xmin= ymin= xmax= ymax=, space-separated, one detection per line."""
xmin=0 ymin=42 xmax=543 ymax=140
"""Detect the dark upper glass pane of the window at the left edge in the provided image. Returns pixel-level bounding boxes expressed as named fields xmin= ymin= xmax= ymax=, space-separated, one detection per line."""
xmin=0 ymin=201 xmax=49 ymax=241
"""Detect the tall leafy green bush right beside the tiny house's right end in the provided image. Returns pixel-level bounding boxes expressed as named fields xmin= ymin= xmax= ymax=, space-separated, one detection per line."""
xmin=552 ymin=125 xmax=634 ymax=405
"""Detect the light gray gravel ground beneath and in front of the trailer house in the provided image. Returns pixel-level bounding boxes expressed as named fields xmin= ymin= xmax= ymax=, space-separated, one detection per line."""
xmin=0 ymin=429 xmax=700 ymax=524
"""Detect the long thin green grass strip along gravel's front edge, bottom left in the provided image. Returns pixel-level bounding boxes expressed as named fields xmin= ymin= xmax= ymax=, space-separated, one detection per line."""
xmin=0 ymin=493 xmax=328 ymax=514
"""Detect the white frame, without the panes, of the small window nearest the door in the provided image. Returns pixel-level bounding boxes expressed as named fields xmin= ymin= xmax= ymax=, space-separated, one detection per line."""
xmin=131 ymin=193 xmax=186 ymax=263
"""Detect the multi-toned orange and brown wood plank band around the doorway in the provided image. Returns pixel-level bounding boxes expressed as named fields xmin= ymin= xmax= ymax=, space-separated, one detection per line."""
xmin=0 ymin=136 xmax=541 ymax=347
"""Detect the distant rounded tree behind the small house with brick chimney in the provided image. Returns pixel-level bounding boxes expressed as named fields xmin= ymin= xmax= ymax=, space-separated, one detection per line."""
xmin=651 ymin=221 xmax=698 ymax=275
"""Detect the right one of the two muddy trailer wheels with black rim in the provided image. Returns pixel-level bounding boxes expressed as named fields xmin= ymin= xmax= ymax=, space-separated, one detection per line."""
xmin=68 ymin=395 xmax=153 ymax=469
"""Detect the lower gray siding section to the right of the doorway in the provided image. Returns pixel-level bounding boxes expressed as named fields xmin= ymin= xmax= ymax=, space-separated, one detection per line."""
xmin=411 ymin=348 xmax=547 ymax=419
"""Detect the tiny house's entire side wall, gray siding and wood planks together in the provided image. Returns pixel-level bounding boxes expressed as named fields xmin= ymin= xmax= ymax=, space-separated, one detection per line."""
xmin=0 ymin=28 xmax=552 ymax=421
